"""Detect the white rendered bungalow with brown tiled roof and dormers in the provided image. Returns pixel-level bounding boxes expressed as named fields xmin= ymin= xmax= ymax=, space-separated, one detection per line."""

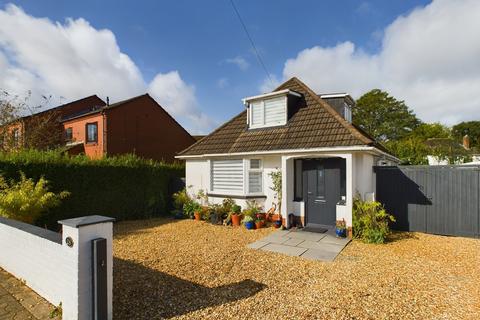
xmin=177 ymin=78 xmax=397 ymax=232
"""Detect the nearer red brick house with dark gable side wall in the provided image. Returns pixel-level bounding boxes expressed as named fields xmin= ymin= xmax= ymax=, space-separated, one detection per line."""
xmin=62 ymin=94 xmax=196 ymax=162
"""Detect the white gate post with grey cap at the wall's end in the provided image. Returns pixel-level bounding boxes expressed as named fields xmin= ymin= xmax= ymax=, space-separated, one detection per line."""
xmin=58 ymin=215 xmax=115 ymax=320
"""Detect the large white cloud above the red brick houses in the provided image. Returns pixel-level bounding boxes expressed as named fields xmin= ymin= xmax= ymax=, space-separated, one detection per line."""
xmin=0 ymin=4 xmax=212 ymax=132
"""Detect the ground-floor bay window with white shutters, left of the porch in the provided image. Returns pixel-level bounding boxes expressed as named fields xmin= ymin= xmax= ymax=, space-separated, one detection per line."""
xmin=210 ymin=159 xmax=263 ymax=195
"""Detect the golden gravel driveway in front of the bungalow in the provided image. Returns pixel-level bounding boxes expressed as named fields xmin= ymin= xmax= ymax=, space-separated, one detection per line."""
xmin=113 ymin=219 xmax=480 ymax=319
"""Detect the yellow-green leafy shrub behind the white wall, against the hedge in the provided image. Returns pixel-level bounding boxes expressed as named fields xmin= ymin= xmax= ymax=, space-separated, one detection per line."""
xmin=0 ymin=172 xmax=70 ymax=223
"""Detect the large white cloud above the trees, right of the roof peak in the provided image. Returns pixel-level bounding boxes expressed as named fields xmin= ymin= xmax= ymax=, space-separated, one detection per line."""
xmin=283 ymin=0 xmax=480 ymax=125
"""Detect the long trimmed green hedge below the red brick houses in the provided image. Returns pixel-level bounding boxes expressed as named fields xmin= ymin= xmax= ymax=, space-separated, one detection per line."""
xmin=0 ymin=150 xmax=185 ymax=229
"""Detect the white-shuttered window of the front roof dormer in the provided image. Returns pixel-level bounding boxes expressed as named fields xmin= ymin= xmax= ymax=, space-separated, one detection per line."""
xmin=250 ymin=96 xmax=287 ymax=128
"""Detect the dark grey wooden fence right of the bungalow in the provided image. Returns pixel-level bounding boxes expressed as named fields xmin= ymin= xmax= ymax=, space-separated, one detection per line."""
xmin=374 ymin=166 xmax=480 ymax=238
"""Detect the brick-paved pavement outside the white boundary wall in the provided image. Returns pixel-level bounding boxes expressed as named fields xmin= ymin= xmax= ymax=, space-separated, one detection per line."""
xmin=0 ymin=269 xmax=58 ymax=320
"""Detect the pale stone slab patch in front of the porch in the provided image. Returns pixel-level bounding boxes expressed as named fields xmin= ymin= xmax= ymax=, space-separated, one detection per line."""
xmin=248 ymin=229 xmax=350 ymax=261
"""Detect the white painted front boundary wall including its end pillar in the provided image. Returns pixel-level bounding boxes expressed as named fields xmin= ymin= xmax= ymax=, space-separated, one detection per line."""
xmin=0 ymin=216 xmax=113 ymax=320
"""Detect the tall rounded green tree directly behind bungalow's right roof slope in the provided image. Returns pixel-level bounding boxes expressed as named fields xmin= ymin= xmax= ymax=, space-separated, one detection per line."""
xmin=353 ymin=89 xmax=421 ymax=142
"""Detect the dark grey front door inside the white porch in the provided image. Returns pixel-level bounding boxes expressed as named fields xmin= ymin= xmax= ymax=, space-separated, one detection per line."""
xmin=303 ymin=158 xmax=345 ymax=226
